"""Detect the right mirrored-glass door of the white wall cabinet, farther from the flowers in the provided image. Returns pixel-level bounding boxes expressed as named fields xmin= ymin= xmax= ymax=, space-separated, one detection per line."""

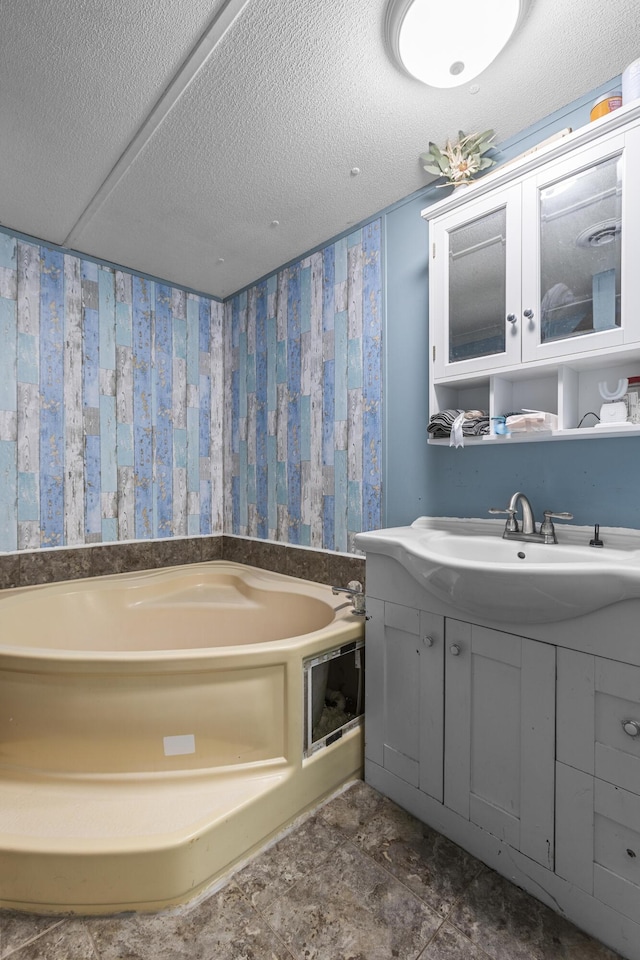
xmin=523 ymin=131 xmax=624 ymax=360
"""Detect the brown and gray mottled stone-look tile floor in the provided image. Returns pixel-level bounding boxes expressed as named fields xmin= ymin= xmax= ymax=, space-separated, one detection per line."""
xmin=0 ymin=782 xmax=618 ymax=960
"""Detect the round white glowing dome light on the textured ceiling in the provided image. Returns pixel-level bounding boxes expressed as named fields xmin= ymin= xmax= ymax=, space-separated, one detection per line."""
xmin=385 ymin=0 xmax=528 ymax=87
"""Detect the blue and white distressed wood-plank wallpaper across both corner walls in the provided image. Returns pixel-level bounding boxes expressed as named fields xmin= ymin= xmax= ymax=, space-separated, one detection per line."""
xmin=0 ymin=220 xmax=382 ymax=551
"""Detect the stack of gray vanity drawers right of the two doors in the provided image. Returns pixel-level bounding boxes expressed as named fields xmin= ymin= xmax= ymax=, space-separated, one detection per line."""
xmin=556 ymin=649 xmax=640 ymax=920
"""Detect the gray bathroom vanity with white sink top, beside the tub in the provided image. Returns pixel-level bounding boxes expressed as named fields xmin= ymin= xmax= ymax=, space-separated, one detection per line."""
xmin=357 ymin=518 xmax=640 ymax=960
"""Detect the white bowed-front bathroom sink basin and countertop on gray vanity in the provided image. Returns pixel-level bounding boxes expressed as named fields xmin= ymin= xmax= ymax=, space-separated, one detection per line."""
xmin=356 ymin=517 xmax=640 ymax=624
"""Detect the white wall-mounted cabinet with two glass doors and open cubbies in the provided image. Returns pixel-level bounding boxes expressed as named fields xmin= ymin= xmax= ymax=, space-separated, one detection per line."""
xmin=423 ymin=99 xmax=640 ymax=442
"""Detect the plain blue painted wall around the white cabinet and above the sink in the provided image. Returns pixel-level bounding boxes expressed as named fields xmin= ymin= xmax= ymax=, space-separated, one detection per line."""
xmin=383 ymin=79 xmax=640 ymax=528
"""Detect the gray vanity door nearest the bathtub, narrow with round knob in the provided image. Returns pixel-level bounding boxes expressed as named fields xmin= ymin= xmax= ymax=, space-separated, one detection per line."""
xmin=365 ymin=598 xmax=444 ymax=801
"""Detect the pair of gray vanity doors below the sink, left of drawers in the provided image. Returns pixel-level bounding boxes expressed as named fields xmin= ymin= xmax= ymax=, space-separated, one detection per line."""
xmin=365 ymin=598 xmax=555 ymax=869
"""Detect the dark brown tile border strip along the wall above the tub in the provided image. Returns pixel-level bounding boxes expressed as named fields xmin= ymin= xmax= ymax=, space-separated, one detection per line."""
xmin=0 ymin=536 xmax=365 ymax=590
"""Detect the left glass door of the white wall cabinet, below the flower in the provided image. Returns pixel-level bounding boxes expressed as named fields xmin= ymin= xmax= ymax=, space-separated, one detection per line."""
xmin=432 ymin=184 xmax=520 ymax=375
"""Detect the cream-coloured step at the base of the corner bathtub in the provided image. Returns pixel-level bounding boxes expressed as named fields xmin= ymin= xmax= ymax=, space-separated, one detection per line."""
xmin=0 ymin=728 xmax=362 ymax=915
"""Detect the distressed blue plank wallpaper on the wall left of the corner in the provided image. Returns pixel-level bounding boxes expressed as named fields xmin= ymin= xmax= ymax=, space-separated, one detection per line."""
xmin=0 ymin=230 xmax=224 ymax=551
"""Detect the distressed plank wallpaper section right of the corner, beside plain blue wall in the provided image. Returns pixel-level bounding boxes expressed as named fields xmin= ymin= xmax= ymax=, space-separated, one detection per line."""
xmin=224 ymin=220 xmax=382 ymax=552
